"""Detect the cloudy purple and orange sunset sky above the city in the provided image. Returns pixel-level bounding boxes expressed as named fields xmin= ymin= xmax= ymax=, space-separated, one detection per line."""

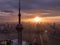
xmin=0 ymin=0 xmax=60 ymax=22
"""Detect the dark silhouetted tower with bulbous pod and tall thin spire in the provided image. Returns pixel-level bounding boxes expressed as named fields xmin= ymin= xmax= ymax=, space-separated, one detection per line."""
xmin=16 ymin=0 xmax=23 ymax=45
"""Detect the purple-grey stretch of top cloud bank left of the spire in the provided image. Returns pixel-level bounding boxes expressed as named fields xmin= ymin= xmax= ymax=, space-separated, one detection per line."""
xmin=0 ymin=0 xmax=18 ymax=10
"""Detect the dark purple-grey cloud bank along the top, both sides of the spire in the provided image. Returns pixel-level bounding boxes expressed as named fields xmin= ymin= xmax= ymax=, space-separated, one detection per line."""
xmin=0 ymin=0 xmax=60 ymax=10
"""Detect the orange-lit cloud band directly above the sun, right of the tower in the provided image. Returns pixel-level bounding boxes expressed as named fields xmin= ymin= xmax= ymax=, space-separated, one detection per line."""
xmin=21 ymin=10 xmax=60 ymax=18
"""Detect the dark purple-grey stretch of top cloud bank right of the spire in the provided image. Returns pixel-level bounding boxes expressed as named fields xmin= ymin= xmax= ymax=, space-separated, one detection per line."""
xmin=21 ymin=0 xmax=60 ymax=10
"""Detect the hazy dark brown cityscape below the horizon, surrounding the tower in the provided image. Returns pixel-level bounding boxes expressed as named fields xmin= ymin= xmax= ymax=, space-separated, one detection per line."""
xmin=0 ymin=22 xmax=60 ymax=45
